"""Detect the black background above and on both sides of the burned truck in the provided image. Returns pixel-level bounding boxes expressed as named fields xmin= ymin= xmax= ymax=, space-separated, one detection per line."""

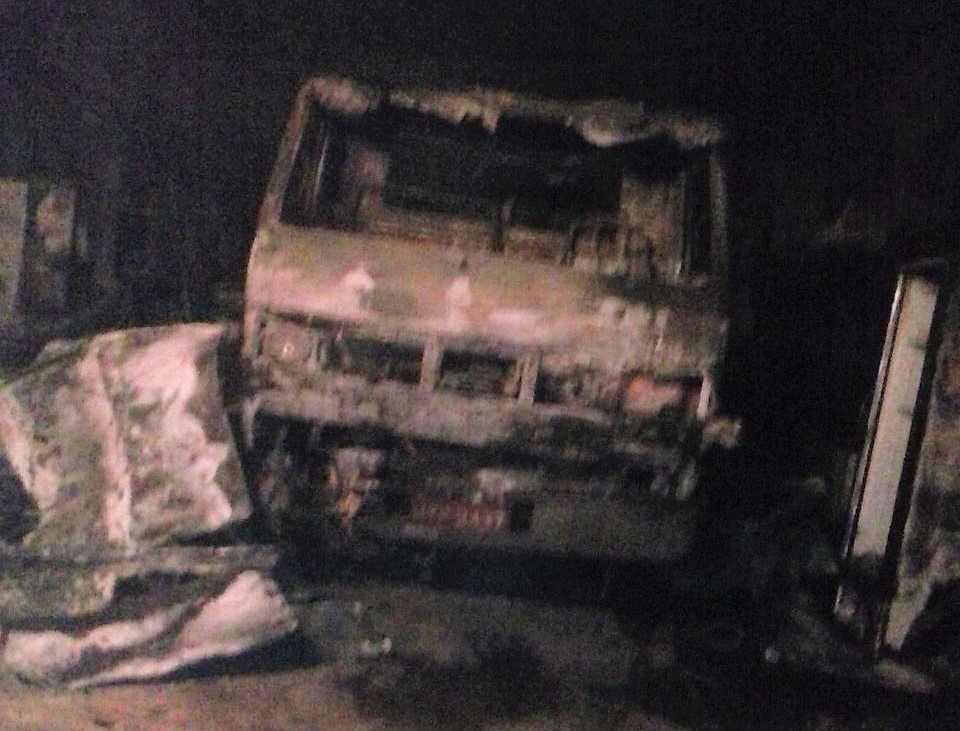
xmin=0 ymin=0 xmax=960 ymax=454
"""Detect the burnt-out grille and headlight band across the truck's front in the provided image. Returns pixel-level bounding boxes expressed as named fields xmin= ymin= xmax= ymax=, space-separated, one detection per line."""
xmin=258 ymin=315 xmax=702 ymax=421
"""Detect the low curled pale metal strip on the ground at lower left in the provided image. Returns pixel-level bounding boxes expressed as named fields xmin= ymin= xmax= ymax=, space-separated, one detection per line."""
xmin=3 ymin=571 xmax=296 ymax=687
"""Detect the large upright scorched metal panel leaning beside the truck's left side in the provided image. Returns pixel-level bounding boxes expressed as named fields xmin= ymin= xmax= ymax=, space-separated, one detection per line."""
xmin=0 ymin=325 xmax=251 ymax=557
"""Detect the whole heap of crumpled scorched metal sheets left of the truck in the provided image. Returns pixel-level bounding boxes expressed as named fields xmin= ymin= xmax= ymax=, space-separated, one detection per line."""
xmin=0 ymin=324 xmax=296 ymax=685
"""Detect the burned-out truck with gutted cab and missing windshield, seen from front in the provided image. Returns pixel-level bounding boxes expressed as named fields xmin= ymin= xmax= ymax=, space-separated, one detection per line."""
xmin=243 ymin=77 xmax=731 ymax=560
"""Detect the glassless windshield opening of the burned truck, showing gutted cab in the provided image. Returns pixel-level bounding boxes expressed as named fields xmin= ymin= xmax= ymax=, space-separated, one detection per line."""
xmin=282 ymin=96 xmax=710 ymax=281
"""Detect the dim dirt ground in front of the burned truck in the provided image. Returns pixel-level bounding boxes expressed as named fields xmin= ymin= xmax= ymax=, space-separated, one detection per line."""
xmin=0 ymin=587 xmax=960 ymax=731
